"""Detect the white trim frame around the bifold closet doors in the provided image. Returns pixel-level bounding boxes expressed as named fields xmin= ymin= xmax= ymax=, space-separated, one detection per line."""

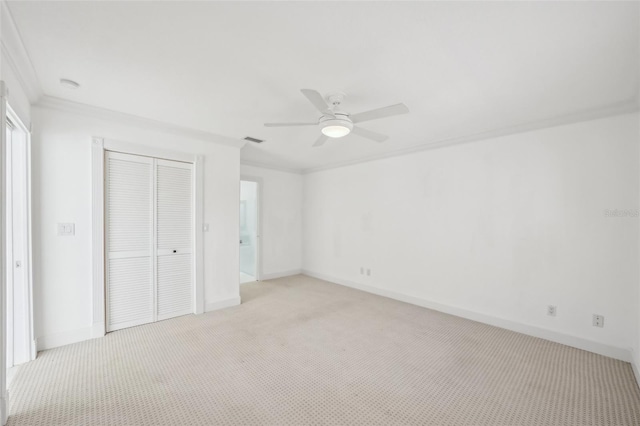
xmin=91 ymin=137 xmax=204 ymax=337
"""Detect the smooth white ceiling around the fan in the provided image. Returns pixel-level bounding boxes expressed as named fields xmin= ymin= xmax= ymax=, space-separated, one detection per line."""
xmin=9 ymin=1 xmax=640 ymax=169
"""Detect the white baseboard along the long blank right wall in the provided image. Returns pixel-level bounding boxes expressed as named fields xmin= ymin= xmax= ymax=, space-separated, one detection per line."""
xmin=302 ymin=270 xmax=638 ymax=362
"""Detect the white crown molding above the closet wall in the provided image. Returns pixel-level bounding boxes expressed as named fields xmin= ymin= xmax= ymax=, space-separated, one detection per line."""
xmin=34 ymin=95 xmax=247 ymax=148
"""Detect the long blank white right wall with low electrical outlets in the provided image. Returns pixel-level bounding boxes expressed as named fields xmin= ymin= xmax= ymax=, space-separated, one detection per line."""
xmin=303 ymin=113 xmax=639 ymax=359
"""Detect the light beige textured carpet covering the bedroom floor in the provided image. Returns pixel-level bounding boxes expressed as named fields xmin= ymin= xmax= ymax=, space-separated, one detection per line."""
xmin=9 ymin=276 xmax=640 ymax=426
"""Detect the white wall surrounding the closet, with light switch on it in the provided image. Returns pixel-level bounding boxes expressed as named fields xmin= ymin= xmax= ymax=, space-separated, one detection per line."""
xmin=32 ymin=107 xmax=240 ymax=349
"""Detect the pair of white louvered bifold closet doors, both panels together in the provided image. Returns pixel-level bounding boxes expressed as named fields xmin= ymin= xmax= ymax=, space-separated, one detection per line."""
xmin=105 ymin=152 xmax=194 ymax=331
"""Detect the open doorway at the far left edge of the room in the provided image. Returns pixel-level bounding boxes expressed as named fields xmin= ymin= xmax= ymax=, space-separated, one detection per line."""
xmin=4 ymin=108 xmax=35 ymax=379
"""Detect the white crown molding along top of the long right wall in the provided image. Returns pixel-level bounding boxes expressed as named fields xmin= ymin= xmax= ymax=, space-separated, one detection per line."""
xmin=302 ymin=96 xmax=640 ymax=174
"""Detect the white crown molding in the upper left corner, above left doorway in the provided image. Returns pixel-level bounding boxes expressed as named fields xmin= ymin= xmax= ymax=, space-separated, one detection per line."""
xmin=0 ymin=0 xmax=43 ymax=103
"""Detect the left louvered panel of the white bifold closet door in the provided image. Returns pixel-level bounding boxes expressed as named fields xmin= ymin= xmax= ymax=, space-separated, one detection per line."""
xmin=105 ymin=152 xmax=155 ymax=331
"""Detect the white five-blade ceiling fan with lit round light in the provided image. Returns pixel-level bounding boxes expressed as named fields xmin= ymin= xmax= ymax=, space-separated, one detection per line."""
xmin=265 ymin=89 xmax=409 ymax=147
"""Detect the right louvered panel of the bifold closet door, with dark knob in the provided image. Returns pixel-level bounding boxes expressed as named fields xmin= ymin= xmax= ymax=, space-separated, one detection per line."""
xmin=156 ymin=160 xmax=193 ymax=320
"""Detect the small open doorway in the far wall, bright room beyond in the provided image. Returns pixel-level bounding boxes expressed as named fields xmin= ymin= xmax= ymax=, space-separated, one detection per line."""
xmin=240 ymin=178 xmax=260 ymax=284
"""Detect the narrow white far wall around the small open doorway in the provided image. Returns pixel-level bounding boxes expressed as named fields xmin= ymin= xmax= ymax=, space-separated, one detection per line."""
xmin=240 ymin=165 xmax=302 ymax=279
